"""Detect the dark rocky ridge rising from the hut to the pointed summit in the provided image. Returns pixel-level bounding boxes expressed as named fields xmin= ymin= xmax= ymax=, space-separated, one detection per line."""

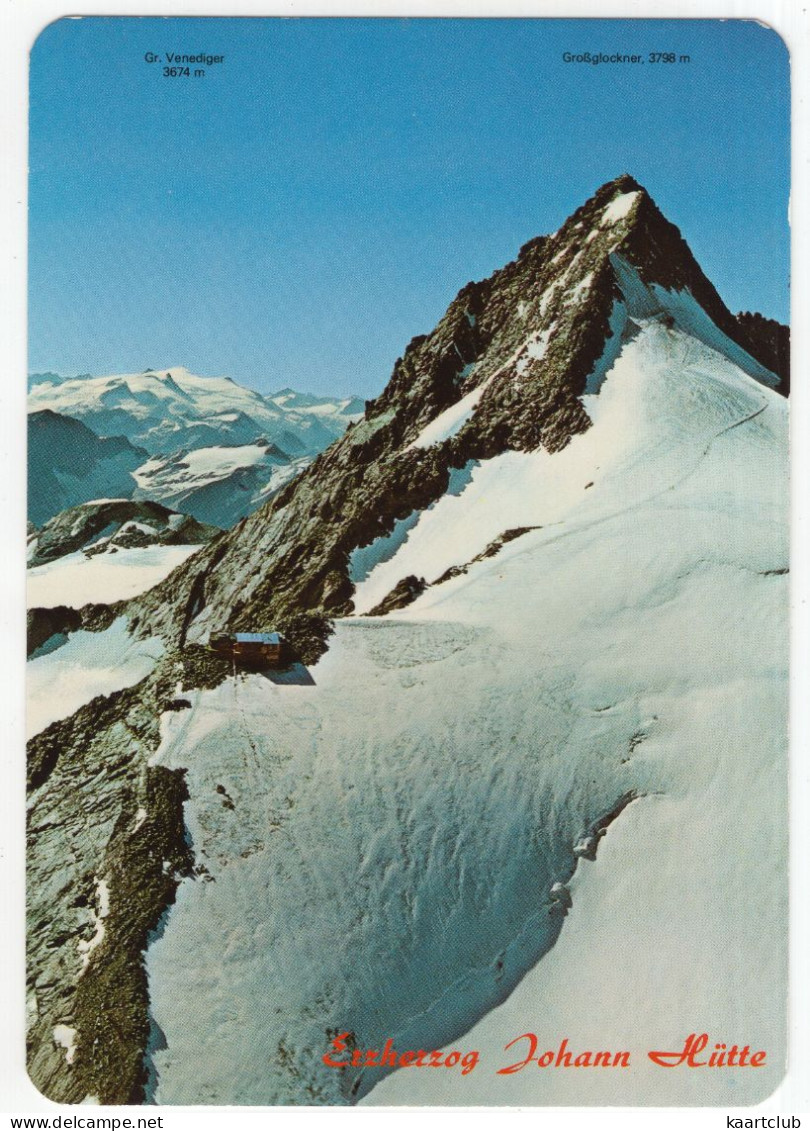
xmin=133 ymin=175 xmax=778 ymax=660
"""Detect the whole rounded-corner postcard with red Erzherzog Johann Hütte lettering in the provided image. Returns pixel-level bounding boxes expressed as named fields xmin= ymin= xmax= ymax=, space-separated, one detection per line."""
xmin=27 ymin=16 xmax=791 ymax=1108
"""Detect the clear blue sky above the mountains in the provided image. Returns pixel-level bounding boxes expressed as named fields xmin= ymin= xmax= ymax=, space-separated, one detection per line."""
xmin=29 ymin=17 xmax=790 ymax=396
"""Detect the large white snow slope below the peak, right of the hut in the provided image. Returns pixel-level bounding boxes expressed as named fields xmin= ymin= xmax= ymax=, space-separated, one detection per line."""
xmin=147 ymin=321 xmax=787 ymax=1104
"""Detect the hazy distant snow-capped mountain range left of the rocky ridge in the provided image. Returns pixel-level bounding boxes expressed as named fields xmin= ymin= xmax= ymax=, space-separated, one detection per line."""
xmin=28 ymin=366 xmax=364 ymax=527
